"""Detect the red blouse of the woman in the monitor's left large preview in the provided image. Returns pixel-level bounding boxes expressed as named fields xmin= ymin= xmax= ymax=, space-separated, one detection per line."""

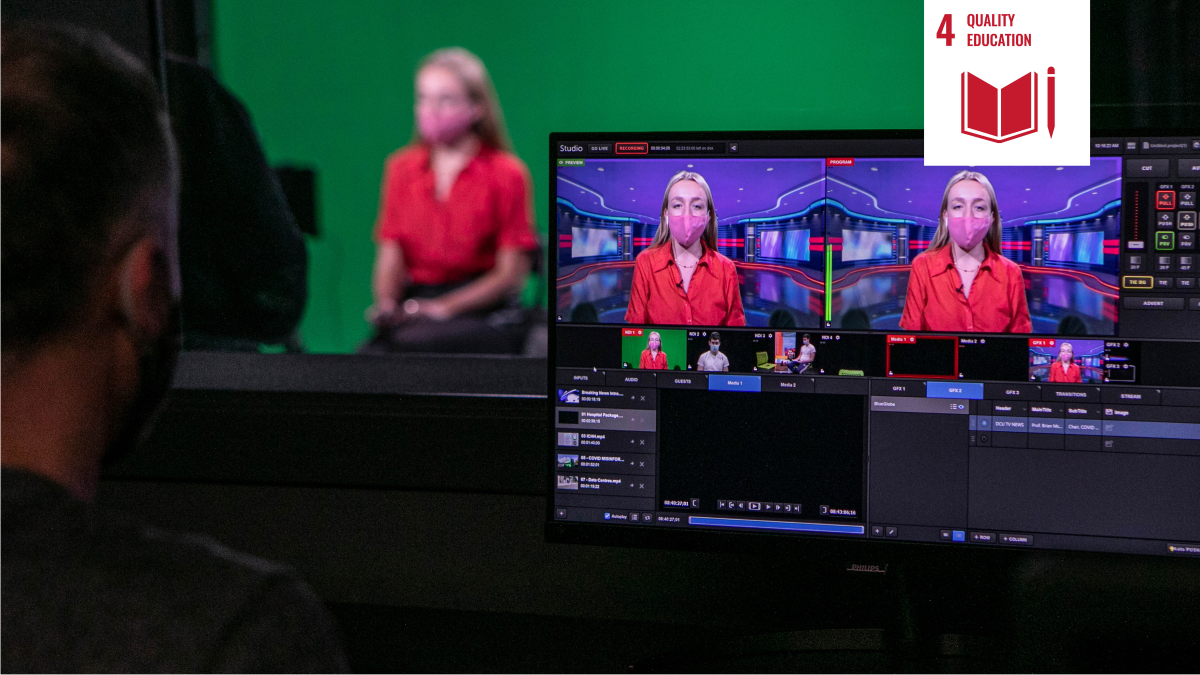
xmin=625 ymin=243 xmax=746 ymax=325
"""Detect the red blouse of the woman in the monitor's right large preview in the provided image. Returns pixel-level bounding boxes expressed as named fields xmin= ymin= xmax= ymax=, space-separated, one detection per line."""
xmin=900 ymin=245 xmax=1033 ymax=333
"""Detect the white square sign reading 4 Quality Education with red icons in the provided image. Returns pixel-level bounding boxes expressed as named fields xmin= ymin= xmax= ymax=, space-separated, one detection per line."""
xmin=922 ymin=0 xmax=1091 ymax=166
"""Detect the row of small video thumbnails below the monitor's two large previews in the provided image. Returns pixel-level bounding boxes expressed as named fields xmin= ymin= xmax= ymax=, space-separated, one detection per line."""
xmin=556 ymin=325 xmax=1141 ymax=384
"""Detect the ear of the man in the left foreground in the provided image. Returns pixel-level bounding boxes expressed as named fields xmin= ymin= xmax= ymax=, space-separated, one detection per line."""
xmin=119 ymin=234 xmax=172 ymax=348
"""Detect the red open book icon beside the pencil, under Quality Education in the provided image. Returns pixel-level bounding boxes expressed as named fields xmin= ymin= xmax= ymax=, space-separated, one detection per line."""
xmin=962 ymin=72 xmax=1038 ymax=143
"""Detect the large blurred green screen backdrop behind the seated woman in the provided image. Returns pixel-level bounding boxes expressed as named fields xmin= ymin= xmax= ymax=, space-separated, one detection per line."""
xmin=212 ymin=0 xmax=923 ymax=353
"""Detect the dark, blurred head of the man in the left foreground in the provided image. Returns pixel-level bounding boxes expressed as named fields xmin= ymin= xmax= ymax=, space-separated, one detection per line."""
xmin=0 ymin=25 xmax=179 ymax=496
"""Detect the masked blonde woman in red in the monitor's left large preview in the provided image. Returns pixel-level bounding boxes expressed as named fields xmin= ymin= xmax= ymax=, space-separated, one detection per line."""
xmin=625 ymin=171 xmax=746 ymax=325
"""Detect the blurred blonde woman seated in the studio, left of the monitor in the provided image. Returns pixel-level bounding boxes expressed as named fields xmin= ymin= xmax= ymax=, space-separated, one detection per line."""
xmin=362 ymin=48 xmax=538 ymax=353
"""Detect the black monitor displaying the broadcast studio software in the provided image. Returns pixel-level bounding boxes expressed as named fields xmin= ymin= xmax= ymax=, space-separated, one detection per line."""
xmin=547 ymin=132 xmax=1200 ymax=556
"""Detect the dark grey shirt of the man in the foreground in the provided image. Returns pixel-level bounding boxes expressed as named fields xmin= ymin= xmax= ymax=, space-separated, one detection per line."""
xmin=0 ymin=468 xmax=347 ymax=673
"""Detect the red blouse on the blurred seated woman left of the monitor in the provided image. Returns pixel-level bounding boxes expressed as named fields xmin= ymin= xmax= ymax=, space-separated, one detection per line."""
xmin=376 ymin=145 xmax=538 ymax=285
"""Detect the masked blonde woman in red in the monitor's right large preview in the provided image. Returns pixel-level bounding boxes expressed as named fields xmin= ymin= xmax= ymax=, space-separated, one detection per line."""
xmin=900 ymin=171 xmax=1033 ymax=333
